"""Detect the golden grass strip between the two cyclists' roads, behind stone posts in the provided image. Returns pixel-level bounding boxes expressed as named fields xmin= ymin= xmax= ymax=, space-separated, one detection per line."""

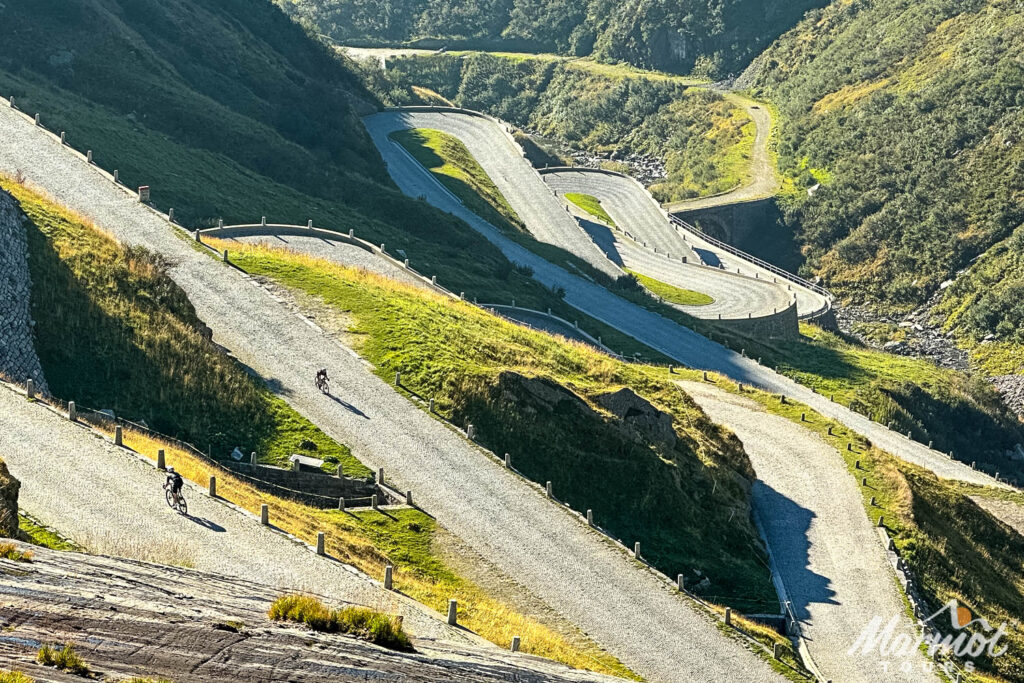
xmin=117 ymin=430 xmax=633 ymax=678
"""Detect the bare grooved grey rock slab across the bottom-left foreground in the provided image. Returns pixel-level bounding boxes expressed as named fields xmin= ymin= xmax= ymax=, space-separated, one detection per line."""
xmin=0 ymin=549 xmax=618 ymax=683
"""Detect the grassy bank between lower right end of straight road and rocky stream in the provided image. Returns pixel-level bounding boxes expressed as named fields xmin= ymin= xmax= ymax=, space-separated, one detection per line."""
xmin=716 ymin=324 xmax=1024 ymax=477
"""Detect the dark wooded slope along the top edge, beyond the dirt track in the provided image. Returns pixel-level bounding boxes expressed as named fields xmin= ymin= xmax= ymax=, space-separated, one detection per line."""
xmin=281 ymin=0 xmax=823 ymax=77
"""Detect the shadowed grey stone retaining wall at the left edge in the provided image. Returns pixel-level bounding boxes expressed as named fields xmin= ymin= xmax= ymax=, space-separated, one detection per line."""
xmin=0 ymin=190 xmax=48 ymax=393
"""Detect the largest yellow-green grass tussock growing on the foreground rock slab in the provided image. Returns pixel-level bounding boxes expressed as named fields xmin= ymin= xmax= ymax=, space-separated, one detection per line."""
xmin=268 ymin=595 xmax=415 ymax=652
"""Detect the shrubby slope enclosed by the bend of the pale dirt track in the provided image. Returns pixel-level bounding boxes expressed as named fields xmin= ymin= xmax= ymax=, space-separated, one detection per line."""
xmin=387 ymin=53 xmax=754 ymax=201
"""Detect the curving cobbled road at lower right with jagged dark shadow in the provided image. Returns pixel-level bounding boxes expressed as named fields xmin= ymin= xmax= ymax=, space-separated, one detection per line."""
xmin=681 ymin=382 xmax=937 ymax=683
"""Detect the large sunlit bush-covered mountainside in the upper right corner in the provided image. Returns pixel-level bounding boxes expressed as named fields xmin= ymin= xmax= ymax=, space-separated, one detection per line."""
xmin=743 ymin=0 xmax=1024 ymax=327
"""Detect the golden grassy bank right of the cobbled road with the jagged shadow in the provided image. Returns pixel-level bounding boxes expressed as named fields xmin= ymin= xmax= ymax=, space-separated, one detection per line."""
xmin=681 ymin=371 xmax=1024 ymax=682
